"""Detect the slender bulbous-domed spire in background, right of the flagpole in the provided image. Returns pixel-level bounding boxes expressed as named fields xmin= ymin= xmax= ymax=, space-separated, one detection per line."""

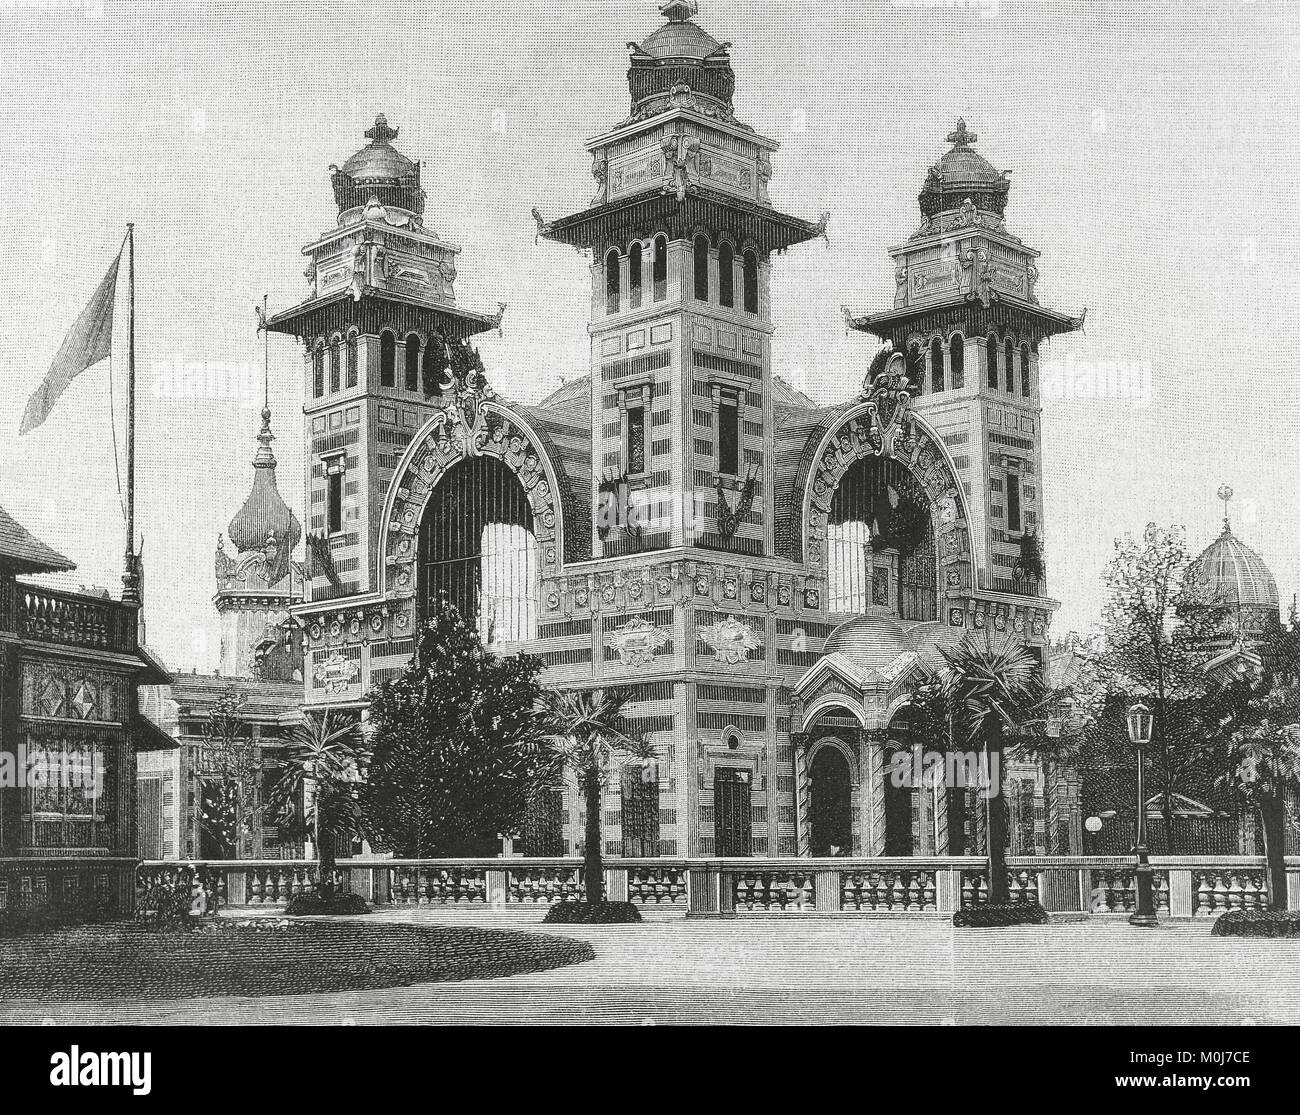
xmin=213 ymin=407 xmax=303 ymax=681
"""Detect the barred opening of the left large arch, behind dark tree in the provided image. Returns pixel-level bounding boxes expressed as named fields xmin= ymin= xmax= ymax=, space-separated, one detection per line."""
xmin=417 ymin=456 xmax=538 ymax=643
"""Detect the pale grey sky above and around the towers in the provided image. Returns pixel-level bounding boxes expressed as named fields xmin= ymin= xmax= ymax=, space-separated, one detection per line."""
xmin=0 ymin=0 xmax=1300 ymax=671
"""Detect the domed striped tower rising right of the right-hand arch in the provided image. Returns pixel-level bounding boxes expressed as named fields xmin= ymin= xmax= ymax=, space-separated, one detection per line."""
xmin=845 ymin=120 xmax=1083 ymax=626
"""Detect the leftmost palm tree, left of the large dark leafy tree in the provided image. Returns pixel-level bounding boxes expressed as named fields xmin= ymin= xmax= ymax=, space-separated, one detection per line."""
xmin=268 ymin=712 xmax=367 ymax=901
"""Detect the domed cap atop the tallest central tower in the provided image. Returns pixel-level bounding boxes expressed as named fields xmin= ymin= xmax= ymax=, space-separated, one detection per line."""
xmin=628 ymin=0 xmax=736 ymax=117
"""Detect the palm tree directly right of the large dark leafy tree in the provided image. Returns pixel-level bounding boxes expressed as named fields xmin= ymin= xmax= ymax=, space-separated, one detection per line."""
xmin=543 ymin=689 xmax=654 ymax=904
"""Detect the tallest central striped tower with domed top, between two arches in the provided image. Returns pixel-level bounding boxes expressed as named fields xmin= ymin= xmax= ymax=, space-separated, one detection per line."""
xmin=538 ymin=0 xmax=826 ymax=558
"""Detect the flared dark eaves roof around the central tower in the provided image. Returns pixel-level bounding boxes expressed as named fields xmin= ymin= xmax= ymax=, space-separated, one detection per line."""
xmin=538 ymin=183 xmax=828 ymax=252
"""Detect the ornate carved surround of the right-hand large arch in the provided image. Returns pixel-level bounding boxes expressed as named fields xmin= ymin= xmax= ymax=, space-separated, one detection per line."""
xmin=803 ymin=352 xmax=972 ymax=591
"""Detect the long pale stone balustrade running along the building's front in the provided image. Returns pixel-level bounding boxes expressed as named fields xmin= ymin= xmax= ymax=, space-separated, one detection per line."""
xmin=137 ymin=856 xmax=1300 ymax=917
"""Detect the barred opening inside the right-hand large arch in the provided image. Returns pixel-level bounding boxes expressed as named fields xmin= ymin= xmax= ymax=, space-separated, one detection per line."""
xmin=827 ymin=456 xmax=939 ymax=620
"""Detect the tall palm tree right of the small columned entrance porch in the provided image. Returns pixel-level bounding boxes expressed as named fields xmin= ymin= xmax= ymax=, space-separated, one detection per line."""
xmin=943 ymin=638 xmax=1044 ymax=904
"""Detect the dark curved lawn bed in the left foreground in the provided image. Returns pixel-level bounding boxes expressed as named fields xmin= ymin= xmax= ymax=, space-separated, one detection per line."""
xmin=0 ymin=919 xmax=594 ymax=1002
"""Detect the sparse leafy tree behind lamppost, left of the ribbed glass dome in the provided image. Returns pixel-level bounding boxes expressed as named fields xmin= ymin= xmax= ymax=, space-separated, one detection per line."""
xmin=1091 ymin=522 xmax=1229 ymax=851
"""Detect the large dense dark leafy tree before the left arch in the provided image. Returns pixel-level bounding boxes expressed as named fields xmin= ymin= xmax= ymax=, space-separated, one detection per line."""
xmin=361 ymin=600 xmax=553 ymax=858
